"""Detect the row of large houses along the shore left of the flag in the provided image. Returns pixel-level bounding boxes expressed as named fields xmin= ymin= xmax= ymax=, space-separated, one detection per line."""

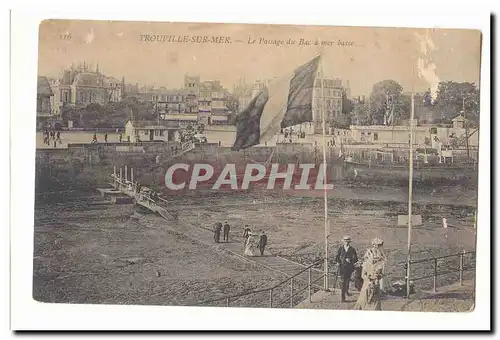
xmin=37 ymin=62 xmax=235 ymax=124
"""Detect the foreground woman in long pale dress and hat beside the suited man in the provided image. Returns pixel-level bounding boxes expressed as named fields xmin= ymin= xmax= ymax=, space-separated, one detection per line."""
xmin=354 ymin=239 xmax=386 ymax=310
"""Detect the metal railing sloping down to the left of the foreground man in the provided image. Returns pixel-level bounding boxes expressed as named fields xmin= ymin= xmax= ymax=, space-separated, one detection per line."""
xmin=196 ymin=259 xmax=332 ymax=308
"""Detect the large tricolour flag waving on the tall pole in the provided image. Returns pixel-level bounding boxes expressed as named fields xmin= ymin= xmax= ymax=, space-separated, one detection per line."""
xmin=232 ymin=56 xmax=320 ymax=150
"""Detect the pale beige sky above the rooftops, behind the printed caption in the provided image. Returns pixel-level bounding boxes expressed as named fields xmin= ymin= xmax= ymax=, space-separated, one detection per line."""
xmin=38 ymin=20 xmax=480 ymax=95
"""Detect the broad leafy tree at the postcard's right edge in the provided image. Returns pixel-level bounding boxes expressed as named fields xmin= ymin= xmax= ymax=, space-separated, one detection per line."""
xmin=435 ymin=81 xmax=479 ymax=123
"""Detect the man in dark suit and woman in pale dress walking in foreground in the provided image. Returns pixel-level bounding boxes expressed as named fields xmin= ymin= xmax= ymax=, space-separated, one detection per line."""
xmin=335 ymin=236 xmax=387 ymax=310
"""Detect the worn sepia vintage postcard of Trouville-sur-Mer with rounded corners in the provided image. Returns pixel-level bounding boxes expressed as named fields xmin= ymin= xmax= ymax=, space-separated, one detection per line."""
xmin=33 ymin=20 xmax=481 ymax=312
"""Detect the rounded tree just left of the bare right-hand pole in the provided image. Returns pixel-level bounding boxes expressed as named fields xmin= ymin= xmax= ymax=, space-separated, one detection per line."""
xmin=369 ymin=79 xmax=408 ymax=124
